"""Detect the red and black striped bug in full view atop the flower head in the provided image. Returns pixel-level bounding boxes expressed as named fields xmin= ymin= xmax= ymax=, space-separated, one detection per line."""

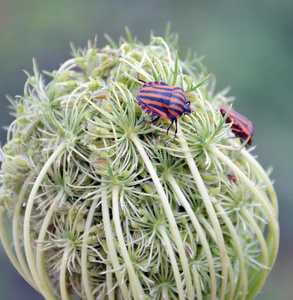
xmin=136 ymin=78 xmax=191 ymax=138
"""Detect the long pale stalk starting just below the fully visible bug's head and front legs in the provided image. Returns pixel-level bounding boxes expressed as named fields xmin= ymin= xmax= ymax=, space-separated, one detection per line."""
xmin=178 ymin=124 xmax=228 ymax=299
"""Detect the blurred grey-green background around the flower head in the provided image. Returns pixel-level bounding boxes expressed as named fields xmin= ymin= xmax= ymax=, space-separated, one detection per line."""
xmin=0 ymin=0 xmax=293 ymax=300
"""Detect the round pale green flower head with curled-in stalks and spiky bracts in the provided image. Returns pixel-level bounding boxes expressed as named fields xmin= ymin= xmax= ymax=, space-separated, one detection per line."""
xmin=0 ymin=31 xmax=279 ymax=299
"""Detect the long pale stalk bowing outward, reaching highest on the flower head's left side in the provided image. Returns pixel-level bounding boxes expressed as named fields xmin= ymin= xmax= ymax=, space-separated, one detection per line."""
xmin=23 ymin=144 xmax=66 ymax=299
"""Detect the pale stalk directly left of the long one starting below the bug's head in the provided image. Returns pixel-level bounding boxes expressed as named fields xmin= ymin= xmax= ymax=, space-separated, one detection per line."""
xmin=165 ymin=173 xmax=217 ymax=300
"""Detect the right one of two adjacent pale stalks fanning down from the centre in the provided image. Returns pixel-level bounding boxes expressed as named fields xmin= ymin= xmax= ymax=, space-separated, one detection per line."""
xmin=112 ymin=185 xmax=145 ymax=299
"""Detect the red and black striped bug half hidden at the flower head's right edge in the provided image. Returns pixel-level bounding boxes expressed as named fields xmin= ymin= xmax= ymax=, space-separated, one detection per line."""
xmin=220 ymin=106 xmax=254 ymax=145
